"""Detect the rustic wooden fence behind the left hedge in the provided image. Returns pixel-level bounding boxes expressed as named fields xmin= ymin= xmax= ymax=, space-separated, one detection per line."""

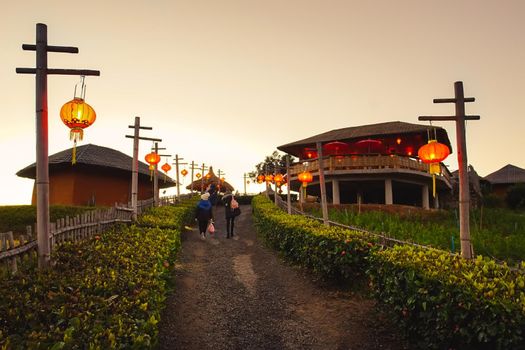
xmin=0 ymin=206 xmax=133 ymax=273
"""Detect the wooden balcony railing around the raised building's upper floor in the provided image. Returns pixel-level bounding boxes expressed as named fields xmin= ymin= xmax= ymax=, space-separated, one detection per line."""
xmin=290 ymin=155 xmax=451 ymax=185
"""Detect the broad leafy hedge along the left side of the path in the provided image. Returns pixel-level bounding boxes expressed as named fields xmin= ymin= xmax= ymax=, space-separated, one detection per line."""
xmin=0 ymin=200 xmax=193 ymax=349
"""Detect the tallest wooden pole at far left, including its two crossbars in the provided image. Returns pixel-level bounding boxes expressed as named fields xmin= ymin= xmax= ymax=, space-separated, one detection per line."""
xmin=16 ymin=23 xmax=100 ymax=269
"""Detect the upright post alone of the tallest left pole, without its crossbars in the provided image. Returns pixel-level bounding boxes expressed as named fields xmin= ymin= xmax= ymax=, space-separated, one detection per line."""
xmin=35 ymin=23 xmax=51 ymax=268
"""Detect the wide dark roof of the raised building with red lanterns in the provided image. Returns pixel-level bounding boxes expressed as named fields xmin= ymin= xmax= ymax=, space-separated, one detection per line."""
xmin=277 ymin=121 xmax=452 ymax=156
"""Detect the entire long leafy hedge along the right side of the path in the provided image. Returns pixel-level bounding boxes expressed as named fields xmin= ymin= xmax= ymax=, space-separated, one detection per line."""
xmin=252 ymin=196 xmax=525 ymax=349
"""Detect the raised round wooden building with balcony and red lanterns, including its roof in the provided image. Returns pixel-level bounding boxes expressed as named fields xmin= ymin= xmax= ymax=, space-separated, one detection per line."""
xmin=277 ymin=121 xmax=452 ymax=209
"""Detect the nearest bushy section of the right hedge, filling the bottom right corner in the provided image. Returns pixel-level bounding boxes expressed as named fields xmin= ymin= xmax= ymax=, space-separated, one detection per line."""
xmin=368 ymin=246 xmax=525 ymax=349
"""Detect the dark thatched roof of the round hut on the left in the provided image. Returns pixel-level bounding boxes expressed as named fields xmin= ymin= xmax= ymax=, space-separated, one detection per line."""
xmin=16 ymin=143 xmax=176 ymax=188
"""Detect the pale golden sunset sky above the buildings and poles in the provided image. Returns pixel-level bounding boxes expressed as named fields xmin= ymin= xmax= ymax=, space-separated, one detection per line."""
xmin=0 ymin=0 xmax=525 ymax=205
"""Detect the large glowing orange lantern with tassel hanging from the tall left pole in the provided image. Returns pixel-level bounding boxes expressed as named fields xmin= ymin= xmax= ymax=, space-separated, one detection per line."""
xmin=60 ymin=97 xmax=97 ymax=164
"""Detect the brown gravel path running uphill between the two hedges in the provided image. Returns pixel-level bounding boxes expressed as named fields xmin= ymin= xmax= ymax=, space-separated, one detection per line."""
xmin=159 ymin=205 xmax=408 ymax=350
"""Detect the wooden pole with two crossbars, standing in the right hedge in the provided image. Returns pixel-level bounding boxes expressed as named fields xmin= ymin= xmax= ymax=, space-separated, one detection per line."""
xmin=418 ymin=81 xmax=480 ymax=259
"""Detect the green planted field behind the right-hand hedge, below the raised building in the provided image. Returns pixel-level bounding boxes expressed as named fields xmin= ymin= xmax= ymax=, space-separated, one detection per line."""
xmin=306 ymin=206 xmax=525 ymax=263
